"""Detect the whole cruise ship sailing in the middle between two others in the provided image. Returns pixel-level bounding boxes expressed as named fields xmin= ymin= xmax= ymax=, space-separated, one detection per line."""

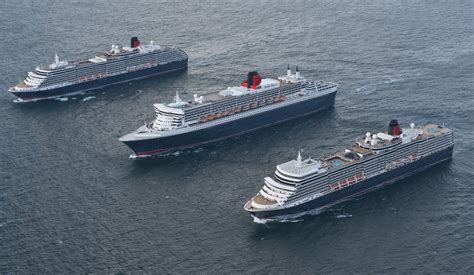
xmin=120 ymin=66 xmax=337 ymax=158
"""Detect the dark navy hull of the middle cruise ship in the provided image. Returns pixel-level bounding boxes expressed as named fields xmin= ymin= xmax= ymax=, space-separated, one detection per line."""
xmin=123 ymin=92 xmax=336 ymax=157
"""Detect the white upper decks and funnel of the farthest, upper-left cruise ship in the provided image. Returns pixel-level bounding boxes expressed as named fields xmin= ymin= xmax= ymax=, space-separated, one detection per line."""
xmin=9 ymin=38 xmax=187 ymax=92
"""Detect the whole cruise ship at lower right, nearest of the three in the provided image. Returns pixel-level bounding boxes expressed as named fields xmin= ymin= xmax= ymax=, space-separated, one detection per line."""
xmin=244 ymin=120 xmax=454 ymax=222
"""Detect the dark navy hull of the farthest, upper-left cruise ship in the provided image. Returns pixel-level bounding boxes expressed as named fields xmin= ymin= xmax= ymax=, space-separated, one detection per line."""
xmin=12 ymin=59 xmax=188 ymax=102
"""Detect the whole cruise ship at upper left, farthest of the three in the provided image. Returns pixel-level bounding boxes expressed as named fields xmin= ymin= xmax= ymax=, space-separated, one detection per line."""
xmin=9 ymin=37 xmax=188 ymax=102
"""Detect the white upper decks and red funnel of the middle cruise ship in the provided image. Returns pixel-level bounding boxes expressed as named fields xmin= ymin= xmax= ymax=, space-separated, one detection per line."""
xmin=129 ymin=67 xmax=337 ymax=138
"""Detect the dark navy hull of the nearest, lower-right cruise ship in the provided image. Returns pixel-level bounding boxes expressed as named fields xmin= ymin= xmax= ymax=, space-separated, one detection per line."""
xmin=250 ymin=146 xmax=453 ymax=220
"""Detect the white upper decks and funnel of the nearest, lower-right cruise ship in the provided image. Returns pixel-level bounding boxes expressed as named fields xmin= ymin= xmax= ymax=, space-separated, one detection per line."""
xmin=244 ymin=123 xmax=454 ymax=216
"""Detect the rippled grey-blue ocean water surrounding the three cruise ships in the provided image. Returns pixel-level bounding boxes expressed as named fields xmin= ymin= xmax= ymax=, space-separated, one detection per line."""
xmin=0 ymin=0 xmax=474 ymax=274
